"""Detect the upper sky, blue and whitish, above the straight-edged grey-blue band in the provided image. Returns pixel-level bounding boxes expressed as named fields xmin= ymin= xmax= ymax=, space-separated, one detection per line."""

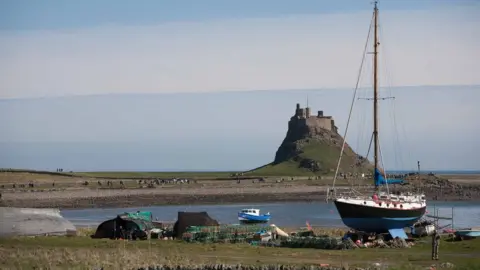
xmin=0 ymin=0 xmax=480 ymax=98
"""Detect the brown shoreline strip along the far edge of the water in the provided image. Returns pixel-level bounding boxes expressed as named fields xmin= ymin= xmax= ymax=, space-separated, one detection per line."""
xmin=0 ymin=188 xmax=480 ymax=210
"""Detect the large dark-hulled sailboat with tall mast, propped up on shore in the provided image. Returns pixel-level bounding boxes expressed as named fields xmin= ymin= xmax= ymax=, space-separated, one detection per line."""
xmin=331 ymin=1 xmax=427 ymax=238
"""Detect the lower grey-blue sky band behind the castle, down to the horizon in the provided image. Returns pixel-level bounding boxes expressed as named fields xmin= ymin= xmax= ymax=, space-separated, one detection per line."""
xmin=0 ymin=86 xmax=480 ymax=170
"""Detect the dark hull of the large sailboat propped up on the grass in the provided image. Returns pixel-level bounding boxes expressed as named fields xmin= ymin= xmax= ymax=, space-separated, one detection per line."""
xmin=335 ymin=201 xmax=426 ymax=233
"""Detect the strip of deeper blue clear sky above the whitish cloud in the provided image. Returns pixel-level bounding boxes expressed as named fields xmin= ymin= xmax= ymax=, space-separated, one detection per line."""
xmin=0 ymin=0 xmax=466 ymax=30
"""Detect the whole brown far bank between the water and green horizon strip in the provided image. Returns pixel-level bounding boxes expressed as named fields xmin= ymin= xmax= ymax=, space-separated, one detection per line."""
xmin=0 ymin=172 xmax=480 ymax=209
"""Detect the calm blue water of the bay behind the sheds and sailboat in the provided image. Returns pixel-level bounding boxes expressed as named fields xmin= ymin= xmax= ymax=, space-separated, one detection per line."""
xmin=62 ymin=202 xmax=480 ymax=228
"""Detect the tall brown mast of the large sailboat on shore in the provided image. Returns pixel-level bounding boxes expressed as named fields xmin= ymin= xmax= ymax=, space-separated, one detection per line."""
xmin=373 ymin=1 xmax=380 ymax=186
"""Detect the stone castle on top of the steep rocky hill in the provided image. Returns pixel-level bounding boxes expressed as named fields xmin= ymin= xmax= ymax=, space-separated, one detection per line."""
xmin=288 ymin=103 xmax=338 ymax=133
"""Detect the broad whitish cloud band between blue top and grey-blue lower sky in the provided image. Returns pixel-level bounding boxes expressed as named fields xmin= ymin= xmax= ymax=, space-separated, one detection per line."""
xmin=0 ymin=6 xmax=480 ymax=98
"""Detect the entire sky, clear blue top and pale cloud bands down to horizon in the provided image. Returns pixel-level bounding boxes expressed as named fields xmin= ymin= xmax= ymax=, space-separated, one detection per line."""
xmin=0 ymin=0 xmax=480 ymax=170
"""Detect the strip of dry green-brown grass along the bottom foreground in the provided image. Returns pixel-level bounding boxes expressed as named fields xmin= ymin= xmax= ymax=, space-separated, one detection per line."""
xmin=0 ymin=237 xmax=480 ymax=269
